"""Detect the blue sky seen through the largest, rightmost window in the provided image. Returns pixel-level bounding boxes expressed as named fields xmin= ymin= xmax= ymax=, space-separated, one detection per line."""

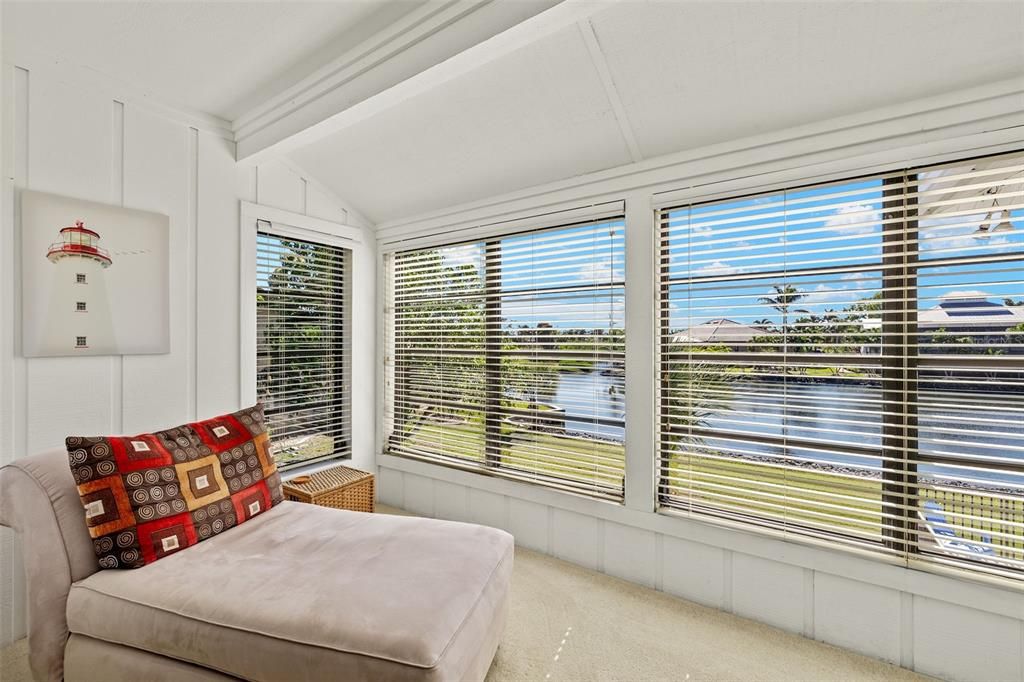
xmin=669 ymin=173 xmax=1024 ymax=329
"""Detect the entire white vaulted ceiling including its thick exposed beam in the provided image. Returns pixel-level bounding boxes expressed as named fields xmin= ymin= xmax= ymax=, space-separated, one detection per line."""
xmin=2 ymin=0 xmax=1024 ymax=223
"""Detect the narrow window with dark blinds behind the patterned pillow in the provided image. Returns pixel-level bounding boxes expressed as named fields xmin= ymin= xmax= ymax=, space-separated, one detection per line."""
xmin=256 ymin=228 xmax=351 ymax=467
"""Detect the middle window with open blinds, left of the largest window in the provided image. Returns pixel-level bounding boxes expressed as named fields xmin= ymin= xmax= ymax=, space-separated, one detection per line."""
xmin=386 ymin=219 xmax=625 ymax=500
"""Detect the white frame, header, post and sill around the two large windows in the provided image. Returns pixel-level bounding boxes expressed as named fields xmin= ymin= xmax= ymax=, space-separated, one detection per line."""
xmin=376 ymin=81 xmax=1024 ymax=598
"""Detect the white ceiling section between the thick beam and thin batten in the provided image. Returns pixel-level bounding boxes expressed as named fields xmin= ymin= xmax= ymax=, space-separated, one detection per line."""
xmin=292 ymin=26 xmax=630 ymax=220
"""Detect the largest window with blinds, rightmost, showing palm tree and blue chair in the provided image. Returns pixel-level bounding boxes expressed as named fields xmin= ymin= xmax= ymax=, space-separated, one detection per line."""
xmin=657 ymin=150 xmax=1024 ymax=577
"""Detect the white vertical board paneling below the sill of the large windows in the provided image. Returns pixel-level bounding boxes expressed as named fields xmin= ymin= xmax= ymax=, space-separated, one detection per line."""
xmin=377 ymin=463 xmax=1024 ymax=682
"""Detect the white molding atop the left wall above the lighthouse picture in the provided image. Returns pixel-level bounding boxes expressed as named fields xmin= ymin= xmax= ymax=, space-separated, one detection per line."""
xmin=5 ymin=50 xmax=234 ymax=141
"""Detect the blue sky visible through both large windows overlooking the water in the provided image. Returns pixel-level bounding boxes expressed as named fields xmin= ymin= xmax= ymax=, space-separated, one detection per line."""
xmin=405 ymin=168 xmax=1024 ymax=329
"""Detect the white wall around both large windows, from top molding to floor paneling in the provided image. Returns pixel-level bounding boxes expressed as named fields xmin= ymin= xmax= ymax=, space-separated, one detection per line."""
xmin=377 ymin=79 xmax=1024 ymax=682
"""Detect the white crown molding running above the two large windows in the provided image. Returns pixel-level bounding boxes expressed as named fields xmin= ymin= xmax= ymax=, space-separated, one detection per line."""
xmin=377 ymin=78 xmax=1024 ymax=241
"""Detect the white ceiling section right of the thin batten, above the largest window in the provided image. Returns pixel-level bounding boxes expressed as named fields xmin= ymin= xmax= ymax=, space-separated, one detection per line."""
xmin=593 ymin=2 xmax=1024 ymax=157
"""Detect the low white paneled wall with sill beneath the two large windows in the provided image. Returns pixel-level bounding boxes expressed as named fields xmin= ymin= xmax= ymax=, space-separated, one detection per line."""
xmin=377 ymin=456 xmax=1024 ymax=682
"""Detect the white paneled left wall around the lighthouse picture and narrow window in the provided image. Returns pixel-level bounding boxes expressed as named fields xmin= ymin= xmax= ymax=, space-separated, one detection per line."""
xmin=0 ymin=61 xmax=376 ymax=645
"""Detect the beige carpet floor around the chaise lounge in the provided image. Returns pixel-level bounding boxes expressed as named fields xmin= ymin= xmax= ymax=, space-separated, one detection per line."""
xmin=0 ymin=501 xmax=925 ymax=682
